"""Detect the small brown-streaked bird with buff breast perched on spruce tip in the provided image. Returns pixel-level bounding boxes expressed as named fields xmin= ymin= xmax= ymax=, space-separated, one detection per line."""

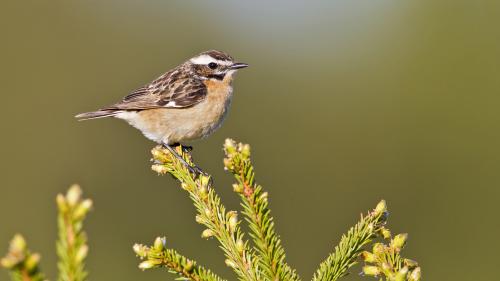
xmin=75 ymin=50 xmax=248 ymax=174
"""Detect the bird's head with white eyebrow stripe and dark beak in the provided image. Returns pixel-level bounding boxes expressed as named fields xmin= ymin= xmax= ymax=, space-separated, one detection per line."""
xmin=186 ymin=50 xmax=248 ymax=81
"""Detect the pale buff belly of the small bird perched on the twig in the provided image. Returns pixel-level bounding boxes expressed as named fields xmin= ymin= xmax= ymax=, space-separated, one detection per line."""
xmin=123 ymin=92 xmax=231 ymax=144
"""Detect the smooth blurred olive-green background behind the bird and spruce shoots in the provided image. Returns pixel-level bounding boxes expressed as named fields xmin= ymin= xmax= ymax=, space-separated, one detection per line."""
xmin=0 ymin=0 xmax=500 ymax=280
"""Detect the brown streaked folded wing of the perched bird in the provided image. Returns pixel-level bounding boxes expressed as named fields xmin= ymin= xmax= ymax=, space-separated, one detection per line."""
xmin=104 ymin=71 xmax=207 ymax=110
